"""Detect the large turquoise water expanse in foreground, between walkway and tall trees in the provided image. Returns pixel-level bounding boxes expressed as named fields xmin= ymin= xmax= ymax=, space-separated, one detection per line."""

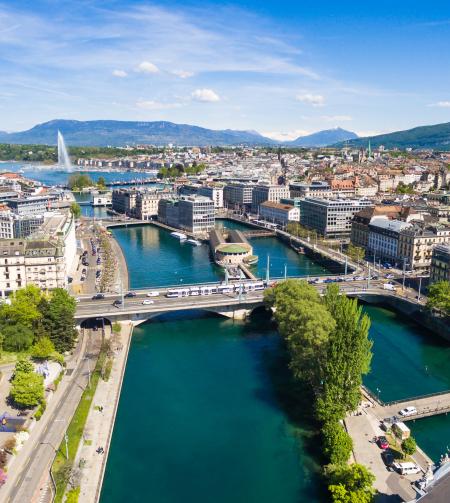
xmin=101 ymin=314 xmax=322 ymax=503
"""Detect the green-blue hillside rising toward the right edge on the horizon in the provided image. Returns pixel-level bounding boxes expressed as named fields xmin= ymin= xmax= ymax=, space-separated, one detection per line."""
xmin=340 ymin=122 xmax=450 ymax=150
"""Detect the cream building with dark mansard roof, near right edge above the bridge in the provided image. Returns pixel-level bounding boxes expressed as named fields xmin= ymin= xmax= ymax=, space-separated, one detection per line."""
xmin=399 ymin=221 xmax=450 ymax=270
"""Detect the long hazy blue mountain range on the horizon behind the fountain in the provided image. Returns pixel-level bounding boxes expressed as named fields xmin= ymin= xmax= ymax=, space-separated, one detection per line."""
xmin=0 ymin=119 xmax=357 ymax=147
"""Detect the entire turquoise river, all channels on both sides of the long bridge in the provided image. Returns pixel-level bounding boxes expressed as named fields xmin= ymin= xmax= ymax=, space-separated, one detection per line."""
xmin=101 ymin=226 xmax=450 ymax=503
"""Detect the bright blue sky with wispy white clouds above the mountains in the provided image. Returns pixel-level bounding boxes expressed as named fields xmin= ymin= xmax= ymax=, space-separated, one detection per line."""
xmin=0 ymin=0 xmax=450 ymax=139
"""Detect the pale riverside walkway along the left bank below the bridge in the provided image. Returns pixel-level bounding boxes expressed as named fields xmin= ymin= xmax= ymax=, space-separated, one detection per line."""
xmin=74 ymin=322 xmax=133 ymax=503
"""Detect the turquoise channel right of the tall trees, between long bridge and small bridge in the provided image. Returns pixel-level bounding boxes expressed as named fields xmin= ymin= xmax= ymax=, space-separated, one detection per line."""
xmin=364 ymin=305 xmax=450 ymax=404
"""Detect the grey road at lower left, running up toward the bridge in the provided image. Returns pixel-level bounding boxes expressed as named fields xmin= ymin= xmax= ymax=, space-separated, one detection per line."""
xmin=0 ymin=331 xmax=101 ymax=503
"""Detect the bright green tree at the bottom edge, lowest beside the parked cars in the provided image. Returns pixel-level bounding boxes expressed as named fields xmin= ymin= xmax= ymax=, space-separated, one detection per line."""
xmin=328 ymin=463 xmax=375 ymax=503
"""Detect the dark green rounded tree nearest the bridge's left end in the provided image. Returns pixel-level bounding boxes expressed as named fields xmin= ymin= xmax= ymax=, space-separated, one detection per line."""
xmin=40 ymin=288 xmax=77 ymax=353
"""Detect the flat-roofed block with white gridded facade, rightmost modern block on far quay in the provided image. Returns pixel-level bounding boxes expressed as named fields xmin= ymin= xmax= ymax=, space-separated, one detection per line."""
xmin=300 ymin=197 xmax=373 ymax=238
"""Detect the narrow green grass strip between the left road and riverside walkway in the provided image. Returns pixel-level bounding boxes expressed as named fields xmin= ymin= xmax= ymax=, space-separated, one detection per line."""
xmin=52 ymin=352 xmax=105 ymax=503
